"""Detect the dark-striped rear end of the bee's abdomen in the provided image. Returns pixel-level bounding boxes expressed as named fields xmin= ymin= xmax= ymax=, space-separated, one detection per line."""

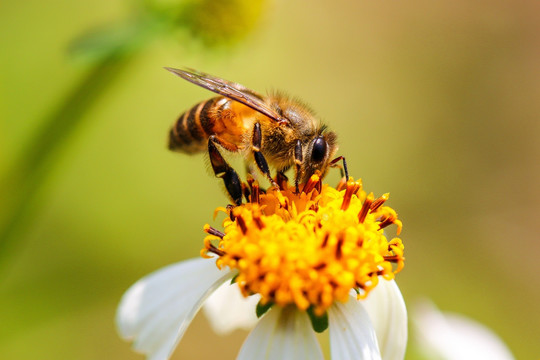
xmin=169 ymin=97 xmax=220 ymax=154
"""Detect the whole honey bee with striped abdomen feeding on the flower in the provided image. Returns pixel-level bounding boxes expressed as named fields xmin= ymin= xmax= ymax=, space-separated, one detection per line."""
xmin=165 ymin=68 xmax=348 ymax=205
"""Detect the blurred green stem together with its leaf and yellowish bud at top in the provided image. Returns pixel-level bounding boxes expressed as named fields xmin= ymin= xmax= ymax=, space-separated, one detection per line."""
xmin=0 ymin=0 xmax=268 ymax=265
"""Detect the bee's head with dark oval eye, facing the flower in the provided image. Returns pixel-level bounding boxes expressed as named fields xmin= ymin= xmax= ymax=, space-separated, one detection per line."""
xmin=301 ymin=128 xmax=337 ymax=183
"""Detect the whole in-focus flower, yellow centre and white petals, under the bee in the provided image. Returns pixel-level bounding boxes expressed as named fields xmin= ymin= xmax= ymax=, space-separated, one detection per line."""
xmin=116 ymin=176 xmax=407 ymax=360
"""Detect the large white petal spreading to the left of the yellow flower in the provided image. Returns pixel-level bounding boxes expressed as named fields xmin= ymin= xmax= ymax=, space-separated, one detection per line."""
xmin=116 ymin=258 xmax=233 ymax=360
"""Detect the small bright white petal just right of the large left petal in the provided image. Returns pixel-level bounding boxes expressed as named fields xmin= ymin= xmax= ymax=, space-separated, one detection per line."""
xmin=203 ymin=282 xmax=261 ymax=335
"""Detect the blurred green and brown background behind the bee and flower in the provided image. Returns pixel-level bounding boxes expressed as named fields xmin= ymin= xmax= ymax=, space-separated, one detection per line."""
xmin=0 ymin=0 xmax=540 ymax=360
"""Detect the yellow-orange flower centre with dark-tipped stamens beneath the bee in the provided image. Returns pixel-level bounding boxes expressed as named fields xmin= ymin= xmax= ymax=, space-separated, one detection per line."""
xmin=201 ymin=175 xmax=404 ymax=316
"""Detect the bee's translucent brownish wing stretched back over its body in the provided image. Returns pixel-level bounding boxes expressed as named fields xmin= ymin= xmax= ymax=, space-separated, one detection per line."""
xmin=165 ymin=67 xmax=289 ymax=123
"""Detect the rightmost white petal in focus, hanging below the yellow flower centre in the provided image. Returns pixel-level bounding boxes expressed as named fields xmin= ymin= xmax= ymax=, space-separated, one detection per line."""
xmin=361 ymin=277 xmax=407 ymax=360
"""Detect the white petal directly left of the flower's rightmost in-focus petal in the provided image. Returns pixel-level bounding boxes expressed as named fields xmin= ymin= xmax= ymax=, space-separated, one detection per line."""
xmin=328 ymin=297 xmax=381 ymax=360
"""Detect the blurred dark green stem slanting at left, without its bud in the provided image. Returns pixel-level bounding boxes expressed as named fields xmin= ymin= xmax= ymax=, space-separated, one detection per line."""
xmin=0 ymin=51 xmax=133 ymax=265
